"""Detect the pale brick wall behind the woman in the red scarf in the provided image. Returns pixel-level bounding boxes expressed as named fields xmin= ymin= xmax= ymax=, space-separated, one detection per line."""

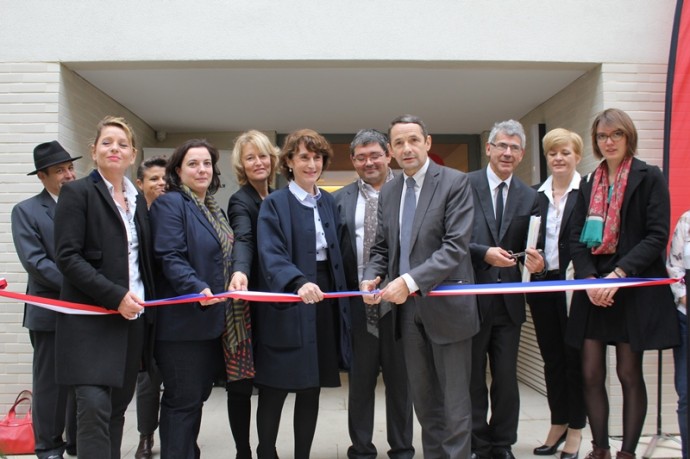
xmin=517 ymin=64 xmax=678 ymax=435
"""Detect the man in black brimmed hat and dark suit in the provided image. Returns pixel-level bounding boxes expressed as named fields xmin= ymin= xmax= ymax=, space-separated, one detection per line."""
xmin=12 ymin=140 xmax=81 ymax=459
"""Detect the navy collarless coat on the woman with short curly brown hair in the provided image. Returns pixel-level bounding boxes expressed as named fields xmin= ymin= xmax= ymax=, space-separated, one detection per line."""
xmin=255 ymin=187 xmax=352 ymax=389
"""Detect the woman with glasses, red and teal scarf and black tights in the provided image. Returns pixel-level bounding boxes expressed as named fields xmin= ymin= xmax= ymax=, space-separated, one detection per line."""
xmin=566 ymin=109 xmax=679 ymax=459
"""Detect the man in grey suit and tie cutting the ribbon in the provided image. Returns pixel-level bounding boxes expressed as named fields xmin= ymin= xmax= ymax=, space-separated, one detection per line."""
xmin=360 ymin=115 xmax=479 ymax=459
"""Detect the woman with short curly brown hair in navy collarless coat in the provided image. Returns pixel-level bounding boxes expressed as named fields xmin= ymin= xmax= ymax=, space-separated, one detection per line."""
xmin=254 ymin=129 xmax=351 ymax=459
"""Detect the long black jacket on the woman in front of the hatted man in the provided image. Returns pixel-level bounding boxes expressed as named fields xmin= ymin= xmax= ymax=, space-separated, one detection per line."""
xmin=55 ymin=170 xmax=155 ymax=387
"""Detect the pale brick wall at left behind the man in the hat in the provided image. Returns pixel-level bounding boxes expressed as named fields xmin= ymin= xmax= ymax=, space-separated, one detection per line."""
xmin=0 ymin=63 xmax=60 ymax=412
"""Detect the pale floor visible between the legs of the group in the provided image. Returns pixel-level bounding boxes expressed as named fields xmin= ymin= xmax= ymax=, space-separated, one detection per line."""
xmin=15 ymin=375 xmax=680 ymax=459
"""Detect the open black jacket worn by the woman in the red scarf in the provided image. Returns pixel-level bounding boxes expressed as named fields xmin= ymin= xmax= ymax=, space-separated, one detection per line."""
xmin=566 ymin=158 xmax=680 ymax=352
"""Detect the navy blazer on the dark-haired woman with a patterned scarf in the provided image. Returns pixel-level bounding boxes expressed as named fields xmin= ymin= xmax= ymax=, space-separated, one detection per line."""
xmin=151 ymin=191 xmax=226 ymax=341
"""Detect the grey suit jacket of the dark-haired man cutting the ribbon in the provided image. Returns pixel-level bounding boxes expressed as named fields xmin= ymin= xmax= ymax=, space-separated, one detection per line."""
xmin=364 ymin=161 xmax=479 ymax=344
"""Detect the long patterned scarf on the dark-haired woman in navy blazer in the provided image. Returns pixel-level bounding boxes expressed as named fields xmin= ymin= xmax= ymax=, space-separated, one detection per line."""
xmin=181 ymin=185 xmax=249 ymax=362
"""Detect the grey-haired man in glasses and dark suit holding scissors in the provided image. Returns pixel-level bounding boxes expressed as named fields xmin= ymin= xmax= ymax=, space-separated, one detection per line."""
xmin=469 ymin=120 xmax=544 ymax=459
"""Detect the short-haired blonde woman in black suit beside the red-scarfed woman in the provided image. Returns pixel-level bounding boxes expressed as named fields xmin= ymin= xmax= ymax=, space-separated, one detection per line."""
xmin=527 ymin=128 xmax=586 ymax=459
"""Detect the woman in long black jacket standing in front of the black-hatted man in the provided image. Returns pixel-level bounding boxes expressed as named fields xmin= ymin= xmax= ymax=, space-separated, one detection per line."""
xmin=55 ymin=116 xmax=154 ymax=459
